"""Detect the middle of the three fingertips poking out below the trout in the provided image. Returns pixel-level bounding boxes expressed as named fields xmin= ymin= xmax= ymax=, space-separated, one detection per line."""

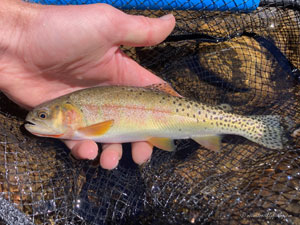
xmin=100 ymin=144 xmax=122 ymax=170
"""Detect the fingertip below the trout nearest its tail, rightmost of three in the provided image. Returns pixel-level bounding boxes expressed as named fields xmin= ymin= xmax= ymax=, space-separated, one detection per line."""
xmin=132 ymin=141 xmax=153 ymax=165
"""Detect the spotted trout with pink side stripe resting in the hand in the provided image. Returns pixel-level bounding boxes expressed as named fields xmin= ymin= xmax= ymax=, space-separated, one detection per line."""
xmin=25 ymin=84 xmax=284 ymax=151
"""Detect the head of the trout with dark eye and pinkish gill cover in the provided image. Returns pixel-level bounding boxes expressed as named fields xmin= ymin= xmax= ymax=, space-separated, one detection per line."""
xmin=25 ymin=102 xmax=81 ymax=139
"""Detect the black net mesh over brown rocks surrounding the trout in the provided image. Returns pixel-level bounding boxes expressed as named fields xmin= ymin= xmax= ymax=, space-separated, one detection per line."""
xmin=0 ymin=2 xmax=300 ymax=224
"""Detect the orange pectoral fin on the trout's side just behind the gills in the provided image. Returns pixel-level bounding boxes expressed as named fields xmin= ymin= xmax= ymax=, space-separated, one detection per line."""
xmin=78 ymin=120 xmax=114 ymax=137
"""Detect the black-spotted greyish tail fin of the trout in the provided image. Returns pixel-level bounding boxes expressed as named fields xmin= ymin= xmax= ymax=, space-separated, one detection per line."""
xmin=246 ymin=115 xmax=287 ymax=149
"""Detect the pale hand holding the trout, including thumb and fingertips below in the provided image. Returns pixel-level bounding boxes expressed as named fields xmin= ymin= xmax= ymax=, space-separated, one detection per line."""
xmin=0 ymin=0 xmax=175 ymax=169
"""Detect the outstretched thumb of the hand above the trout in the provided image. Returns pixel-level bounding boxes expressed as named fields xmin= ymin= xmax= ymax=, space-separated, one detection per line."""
xmin=115 ymin=13 xmax=175 ymax=47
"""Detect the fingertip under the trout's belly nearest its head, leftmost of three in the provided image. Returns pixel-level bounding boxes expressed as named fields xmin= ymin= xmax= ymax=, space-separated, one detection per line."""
xmin=64 ymin=140 xmax=98 ymax=159
